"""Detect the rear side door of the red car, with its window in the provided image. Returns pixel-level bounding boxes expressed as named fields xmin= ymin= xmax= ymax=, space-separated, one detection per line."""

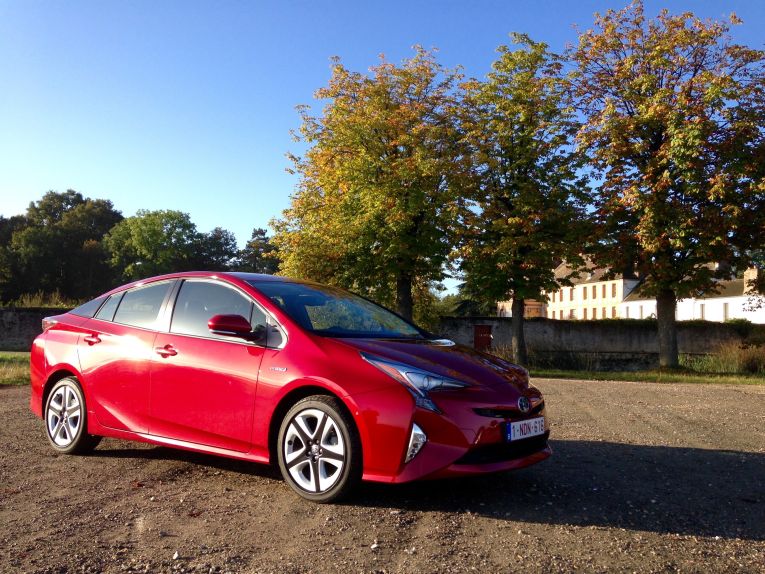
xmin=77 ymin=281 xmax=174 ymax=433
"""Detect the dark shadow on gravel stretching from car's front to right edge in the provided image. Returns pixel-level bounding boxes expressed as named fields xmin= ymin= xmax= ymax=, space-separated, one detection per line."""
xmin=348 ymin=441 xmax=765 ymax=540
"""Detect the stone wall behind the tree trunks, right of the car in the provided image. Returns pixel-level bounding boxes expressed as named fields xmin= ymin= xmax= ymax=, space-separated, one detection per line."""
xmin=439 ymin=317 xmax=765 ymax=370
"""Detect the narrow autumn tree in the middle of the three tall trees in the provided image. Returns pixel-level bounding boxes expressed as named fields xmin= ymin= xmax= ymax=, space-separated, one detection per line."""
xmin=459 ymin=34 xmax=587 ymax=364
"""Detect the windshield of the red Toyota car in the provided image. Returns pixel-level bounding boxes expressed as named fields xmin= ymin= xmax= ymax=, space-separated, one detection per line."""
xmin=249 ymin=281 xmax=423 ymax=339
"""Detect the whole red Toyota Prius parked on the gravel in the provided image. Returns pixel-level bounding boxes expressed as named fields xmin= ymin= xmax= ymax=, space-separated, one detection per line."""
xmin=31 ymin=272 xmax=551 ymax=502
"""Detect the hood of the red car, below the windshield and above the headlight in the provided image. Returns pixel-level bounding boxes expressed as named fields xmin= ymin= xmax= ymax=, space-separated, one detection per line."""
xmin=335 ymin=339 xmax=529 ymax=389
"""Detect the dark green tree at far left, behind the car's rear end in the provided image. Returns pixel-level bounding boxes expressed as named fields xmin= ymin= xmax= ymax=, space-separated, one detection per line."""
xmin=6 ymin=190 xmax=122 ymax=299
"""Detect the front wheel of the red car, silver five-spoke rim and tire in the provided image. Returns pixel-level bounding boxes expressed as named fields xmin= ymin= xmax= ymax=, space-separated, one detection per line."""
xmin=276 ymin=395 xmax=362 ymax=503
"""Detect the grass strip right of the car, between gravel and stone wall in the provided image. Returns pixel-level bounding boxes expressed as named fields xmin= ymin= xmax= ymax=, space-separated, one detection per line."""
xmin=531 ymin=368 xmax=765 ymax=385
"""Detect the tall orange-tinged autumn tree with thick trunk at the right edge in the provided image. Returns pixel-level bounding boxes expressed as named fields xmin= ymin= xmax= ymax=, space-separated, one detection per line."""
xmin=571 ymin=2 xmax=765 ymax=367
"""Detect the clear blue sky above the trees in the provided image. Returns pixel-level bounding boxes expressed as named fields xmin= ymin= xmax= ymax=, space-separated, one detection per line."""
xmin=0 ymin=0 xmax=765 ymax=252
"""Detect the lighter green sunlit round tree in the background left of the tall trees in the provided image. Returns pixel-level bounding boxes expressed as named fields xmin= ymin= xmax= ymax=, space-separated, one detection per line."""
xmin=104 ymin=209 xmax=199 ymax=281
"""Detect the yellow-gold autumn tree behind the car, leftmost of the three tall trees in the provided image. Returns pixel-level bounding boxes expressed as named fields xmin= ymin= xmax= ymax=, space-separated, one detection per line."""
xmin=272 ymin=48 xmax=468 ymax=318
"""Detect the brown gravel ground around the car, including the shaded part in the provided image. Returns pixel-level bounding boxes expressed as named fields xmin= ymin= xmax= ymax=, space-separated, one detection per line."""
xmin=0 ymin=379 xmax=765 ymax=574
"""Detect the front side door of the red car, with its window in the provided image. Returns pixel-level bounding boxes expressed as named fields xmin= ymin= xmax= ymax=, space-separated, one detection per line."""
xmin=149 ymin=279 xmax=266 ymax=452
